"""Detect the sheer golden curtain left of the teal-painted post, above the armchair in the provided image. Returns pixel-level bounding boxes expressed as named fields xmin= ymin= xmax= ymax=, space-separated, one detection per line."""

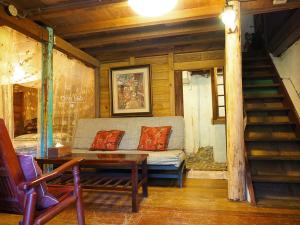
xmin=0 ymin=26 xmax=41 ymax=138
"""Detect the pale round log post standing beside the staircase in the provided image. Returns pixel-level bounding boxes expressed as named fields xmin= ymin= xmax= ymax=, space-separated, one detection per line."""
xmin=225 ymin=0 xmax=246 ymax=201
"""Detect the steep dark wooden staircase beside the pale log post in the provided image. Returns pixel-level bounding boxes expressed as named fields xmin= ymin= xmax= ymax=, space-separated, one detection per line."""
xmin=243 ymin=51 xmax=300 ymax=208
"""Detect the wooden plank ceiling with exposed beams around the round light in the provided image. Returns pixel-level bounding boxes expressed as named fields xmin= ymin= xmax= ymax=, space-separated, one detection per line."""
xmin=6 ymin=0 xmax=300 ymax=61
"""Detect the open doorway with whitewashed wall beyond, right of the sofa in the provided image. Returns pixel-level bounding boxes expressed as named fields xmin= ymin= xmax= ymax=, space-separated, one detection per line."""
xmin=175 ymin=68 xmax=227 ymax=171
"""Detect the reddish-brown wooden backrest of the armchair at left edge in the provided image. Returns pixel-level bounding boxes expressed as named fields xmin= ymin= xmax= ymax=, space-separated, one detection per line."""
xmin=0 ymin=119 xmax=25 ymax=214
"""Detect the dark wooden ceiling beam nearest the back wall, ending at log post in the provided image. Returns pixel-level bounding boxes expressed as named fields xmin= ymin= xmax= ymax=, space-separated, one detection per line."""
xmin=86 ymin=32 xmax=225 ymax=55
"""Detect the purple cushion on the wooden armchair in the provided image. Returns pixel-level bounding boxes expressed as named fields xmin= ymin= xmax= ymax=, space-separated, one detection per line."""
xmin=18 ymin=154 xmax=58 ymax=209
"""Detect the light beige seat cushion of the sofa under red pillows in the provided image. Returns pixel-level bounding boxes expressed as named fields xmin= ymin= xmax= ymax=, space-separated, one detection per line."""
xmin=72 ymin=149 xmax=186 ymax=167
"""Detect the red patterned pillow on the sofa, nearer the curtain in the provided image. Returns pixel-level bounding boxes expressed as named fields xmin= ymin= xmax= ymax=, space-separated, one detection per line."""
xmin=90 ymin=130 xmax=125 ymax=151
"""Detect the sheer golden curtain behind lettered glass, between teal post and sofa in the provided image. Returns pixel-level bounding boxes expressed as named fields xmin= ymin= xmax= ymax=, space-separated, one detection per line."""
xmin=53 ymin=50 xmax=95 ymax=145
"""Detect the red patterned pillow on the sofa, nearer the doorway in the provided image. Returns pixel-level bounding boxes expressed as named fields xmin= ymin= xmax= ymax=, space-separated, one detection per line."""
xmin=138 ymin=126 xmax=172 ymax=151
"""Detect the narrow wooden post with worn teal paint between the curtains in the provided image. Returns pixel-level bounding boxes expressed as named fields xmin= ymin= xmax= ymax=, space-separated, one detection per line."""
xmin=40 ymin=28 xmax=54 ymax=156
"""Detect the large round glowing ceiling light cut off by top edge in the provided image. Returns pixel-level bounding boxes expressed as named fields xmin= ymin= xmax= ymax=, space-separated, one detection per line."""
xmin=128 ymin=0 xmax=177 ymax=17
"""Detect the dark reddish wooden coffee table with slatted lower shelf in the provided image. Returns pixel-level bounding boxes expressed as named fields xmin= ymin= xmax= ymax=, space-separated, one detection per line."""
xmin=36 ymin=153 xmax=148 ymax=212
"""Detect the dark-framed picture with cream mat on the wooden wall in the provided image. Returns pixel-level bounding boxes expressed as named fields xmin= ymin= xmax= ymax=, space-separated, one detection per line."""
xmin=110 ymin=65 xmax=152 ymax=117
